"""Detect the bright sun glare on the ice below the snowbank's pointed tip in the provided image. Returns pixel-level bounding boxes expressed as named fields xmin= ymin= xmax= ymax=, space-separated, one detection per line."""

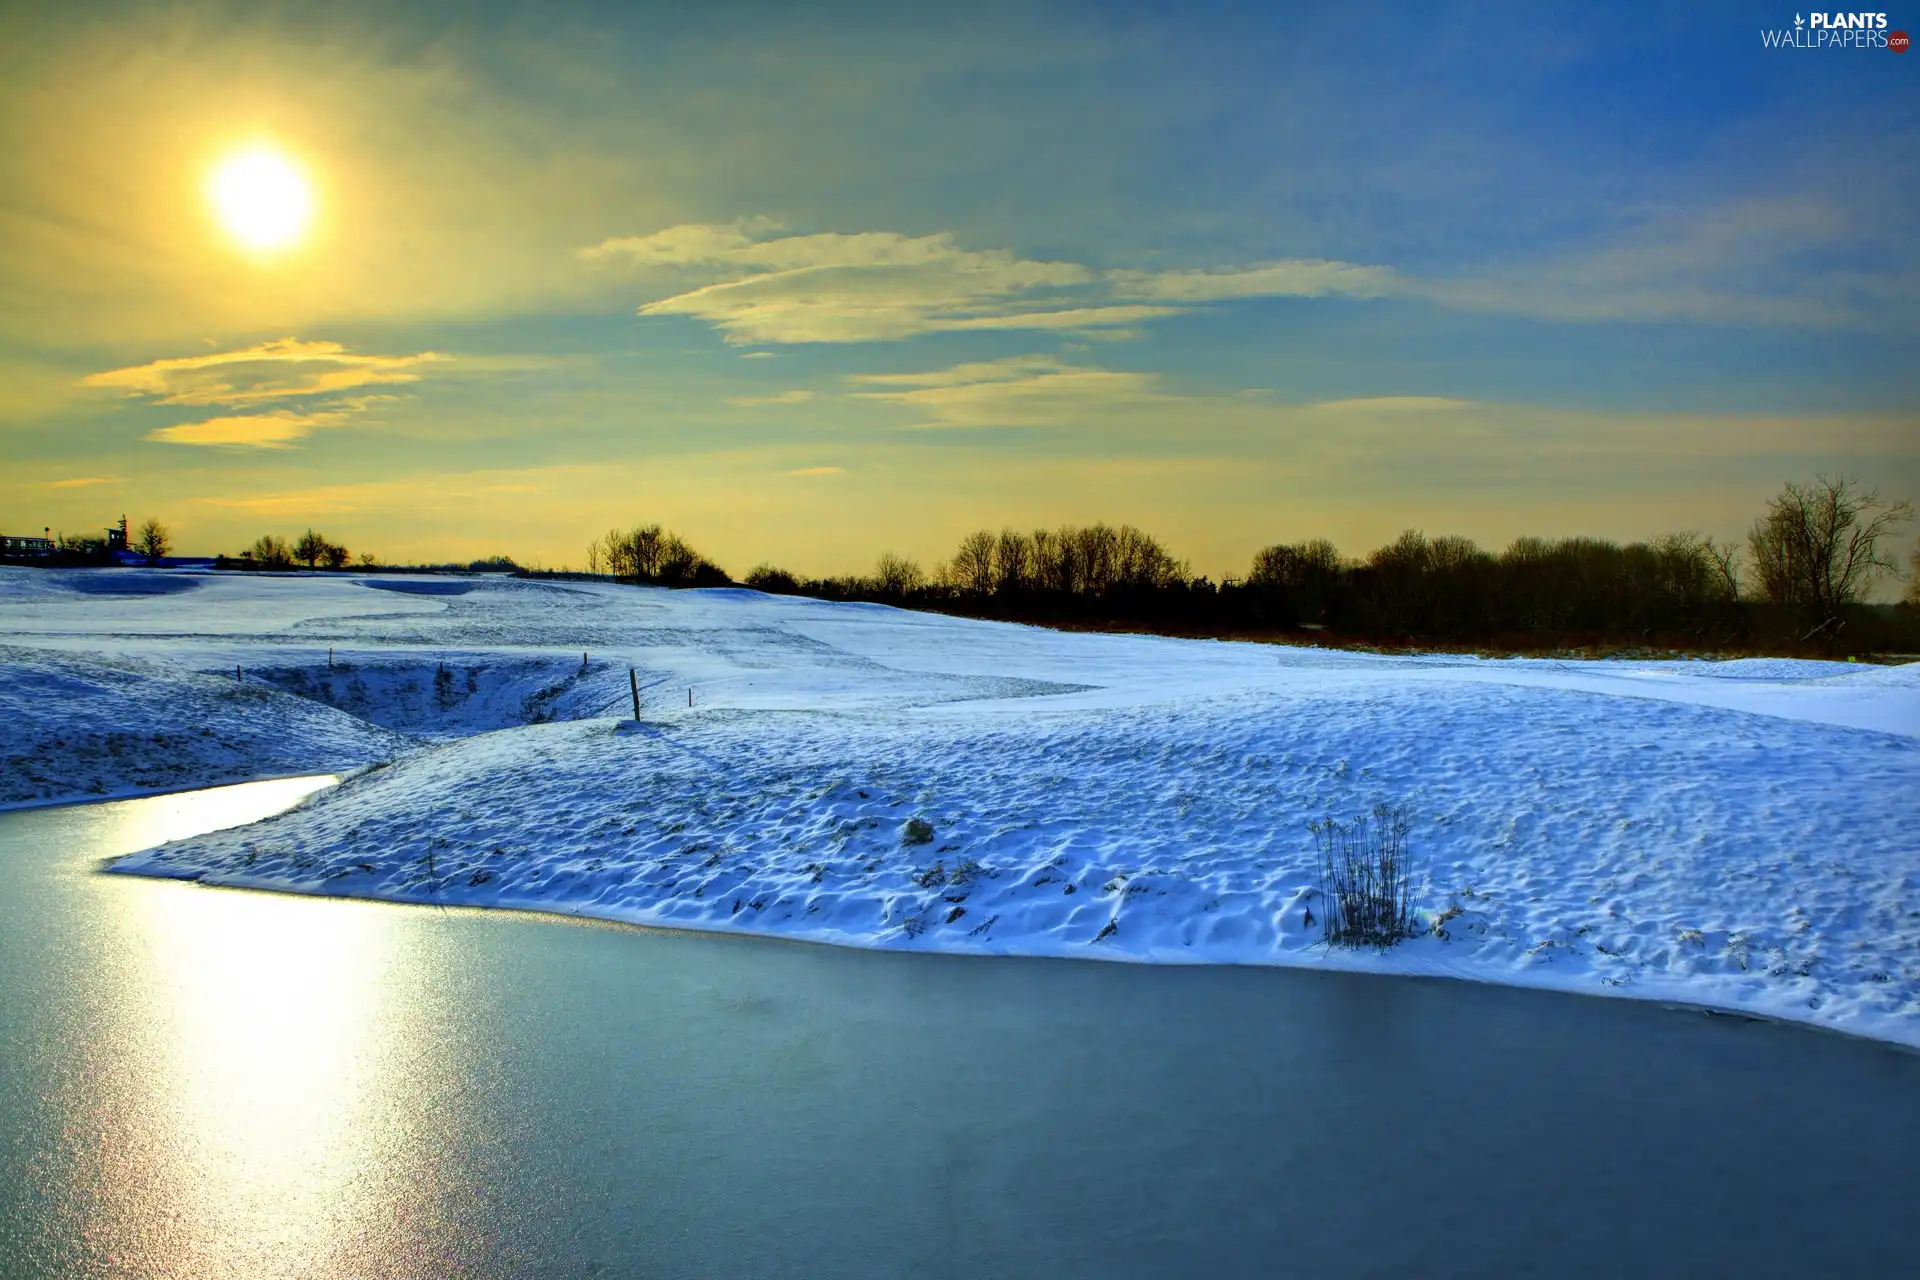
xmin=123 ymin=892 xmax=403 ymax=1276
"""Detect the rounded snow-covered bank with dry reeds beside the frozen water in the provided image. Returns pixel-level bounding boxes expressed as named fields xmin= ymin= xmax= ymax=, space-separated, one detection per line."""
xmin=121 ymin=681 xmax=1920 ymax=1044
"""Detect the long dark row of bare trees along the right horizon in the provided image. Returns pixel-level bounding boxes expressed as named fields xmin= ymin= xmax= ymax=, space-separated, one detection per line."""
xmin=725 ymin=476 xmax=1920 ymax=651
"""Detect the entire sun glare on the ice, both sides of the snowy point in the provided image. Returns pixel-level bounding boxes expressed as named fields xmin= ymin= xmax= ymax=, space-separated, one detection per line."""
xmin=0 ymin=777 xmax=487 ymax=1280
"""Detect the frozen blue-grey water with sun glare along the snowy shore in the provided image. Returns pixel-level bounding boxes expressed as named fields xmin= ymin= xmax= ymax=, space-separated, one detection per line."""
xmin=0 ymin=783 xmax=1920 ymax=1280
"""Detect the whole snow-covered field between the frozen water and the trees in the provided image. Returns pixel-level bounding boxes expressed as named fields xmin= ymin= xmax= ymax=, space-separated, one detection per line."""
xmin=11 ymin=570 xmax=1920 ymax=1046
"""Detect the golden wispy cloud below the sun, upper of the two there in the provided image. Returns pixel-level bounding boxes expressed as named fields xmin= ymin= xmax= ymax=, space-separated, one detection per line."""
xmin=81 ymin=338 xmax=449 ymax=409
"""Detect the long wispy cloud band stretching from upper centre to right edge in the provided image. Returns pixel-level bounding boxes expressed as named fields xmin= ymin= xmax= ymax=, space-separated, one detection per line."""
xmin=582 ymin=201 xmax=1916 ymax=344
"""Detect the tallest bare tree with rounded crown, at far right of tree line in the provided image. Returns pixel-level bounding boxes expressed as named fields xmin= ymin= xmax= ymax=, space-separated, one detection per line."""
xmin=1747 ymin=476 xmax=1914 ymax=629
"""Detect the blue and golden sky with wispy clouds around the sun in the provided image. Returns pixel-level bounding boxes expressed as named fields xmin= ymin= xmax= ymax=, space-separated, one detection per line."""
xmin=0 ymin=4 xmax=1920 ymax=576
